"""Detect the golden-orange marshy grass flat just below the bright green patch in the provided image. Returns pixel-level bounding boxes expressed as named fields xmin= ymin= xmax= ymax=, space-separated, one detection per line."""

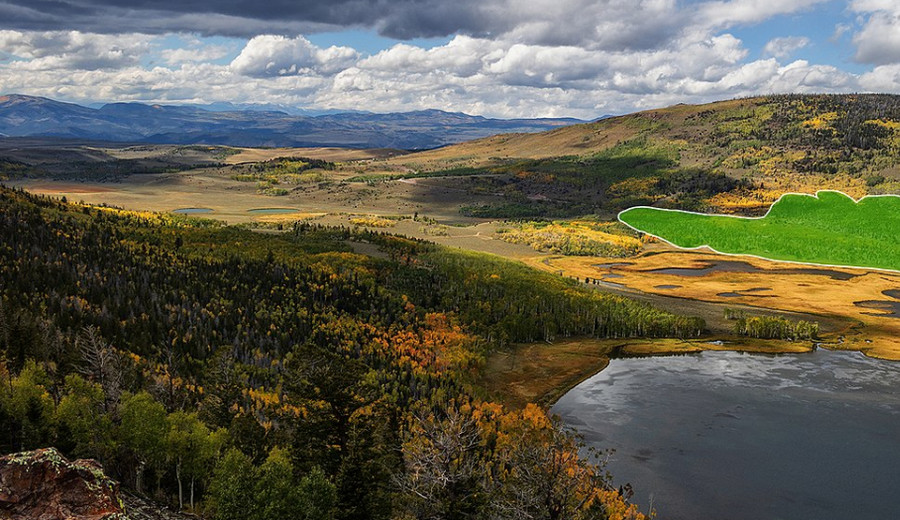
xmin=529 ymin=250 xmax=900 ymax=360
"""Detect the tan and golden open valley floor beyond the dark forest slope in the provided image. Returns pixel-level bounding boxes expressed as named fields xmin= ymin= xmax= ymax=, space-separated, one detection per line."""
xmin=7 ymin=150 xmax=900 ymax=418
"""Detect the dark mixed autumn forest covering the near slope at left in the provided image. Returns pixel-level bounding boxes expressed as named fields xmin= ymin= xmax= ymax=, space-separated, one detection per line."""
xmin=0 ymin=188 xmax=704 ymax=520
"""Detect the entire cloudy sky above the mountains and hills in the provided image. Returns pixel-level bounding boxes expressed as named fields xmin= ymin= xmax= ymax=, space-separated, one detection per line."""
xmin=0 ymin=0 xmax=900 ymax=119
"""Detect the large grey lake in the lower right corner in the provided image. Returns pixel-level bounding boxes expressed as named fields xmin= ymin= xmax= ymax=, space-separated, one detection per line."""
xmin=553 ymin=349 xmax=900 ymax=520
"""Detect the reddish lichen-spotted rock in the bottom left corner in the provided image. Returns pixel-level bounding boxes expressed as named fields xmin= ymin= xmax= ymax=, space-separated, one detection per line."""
xmin=0 ymin=448 xmax=126 ymax=520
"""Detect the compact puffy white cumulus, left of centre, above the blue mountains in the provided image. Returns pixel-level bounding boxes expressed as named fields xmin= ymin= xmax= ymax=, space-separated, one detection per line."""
xmin=231 ymin=35 xmax=359 ymax=77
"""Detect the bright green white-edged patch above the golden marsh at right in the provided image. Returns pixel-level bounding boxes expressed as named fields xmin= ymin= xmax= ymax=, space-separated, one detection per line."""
xmin=619 ymin=191 xmax=900 ymax=271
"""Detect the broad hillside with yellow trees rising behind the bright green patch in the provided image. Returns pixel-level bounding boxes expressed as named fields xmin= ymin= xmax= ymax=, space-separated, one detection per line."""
xmin=386 ymin=94 xmax=900 ymax=217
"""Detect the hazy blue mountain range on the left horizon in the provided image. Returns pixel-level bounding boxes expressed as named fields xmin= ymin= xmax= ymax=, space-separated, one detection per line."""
xmin=0 ymin=94 xmax=584 ymax=150
